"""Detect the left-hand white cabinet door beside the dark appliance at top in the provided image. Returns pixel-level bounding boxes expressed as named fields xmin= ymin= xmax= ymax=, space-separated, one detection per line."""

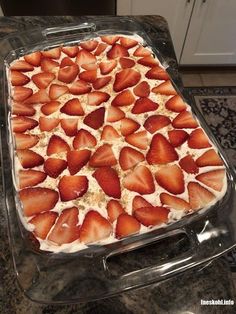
xmin=117 ymin=0 xmax=195 ymax=60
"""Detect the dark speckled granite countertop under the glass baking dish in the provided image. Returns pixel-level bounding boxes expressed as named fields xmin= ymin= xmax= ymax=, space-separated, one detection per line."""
xmin=0 ymin=16 xmax=236 ymax=314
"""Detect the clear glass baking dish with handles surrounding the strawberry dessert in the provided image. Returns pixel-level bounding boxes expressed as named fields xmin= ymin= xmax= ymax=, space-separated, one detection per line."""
xmin=1 ymin=17 xmax=236 ymax=304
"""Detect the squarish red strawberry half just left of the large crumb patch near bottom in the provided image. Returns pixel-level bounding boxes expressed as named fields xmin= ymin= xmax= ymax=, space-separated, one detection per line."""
xmin=58 ymin=176 xmax=88 ymax=202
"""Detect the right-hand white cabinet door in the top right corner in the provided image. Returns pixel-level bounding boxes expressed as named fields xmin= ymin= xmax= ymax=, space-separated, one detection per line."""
xmin=181 ymin=0 xmax=236 ymax=65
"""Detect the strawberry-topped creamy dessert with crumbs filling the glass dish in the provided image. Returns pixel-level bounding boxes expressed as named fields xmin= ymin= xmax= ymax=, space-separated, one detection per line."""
xmin=8 ymin=34 xmax=227 ymax=253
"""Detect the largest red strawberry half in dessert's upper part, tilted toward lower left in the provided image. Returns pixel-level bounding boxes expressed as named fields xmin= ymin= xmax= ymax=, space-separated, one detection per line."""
xmin=113 ymin=69 xmax=141 ymax=92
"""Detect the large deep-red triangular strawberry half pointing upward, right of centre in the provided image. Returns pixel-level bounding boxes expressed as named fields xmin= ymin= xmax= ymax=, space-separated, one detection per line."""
xmin=146 ymin=133 xmax=179 ymax=165
